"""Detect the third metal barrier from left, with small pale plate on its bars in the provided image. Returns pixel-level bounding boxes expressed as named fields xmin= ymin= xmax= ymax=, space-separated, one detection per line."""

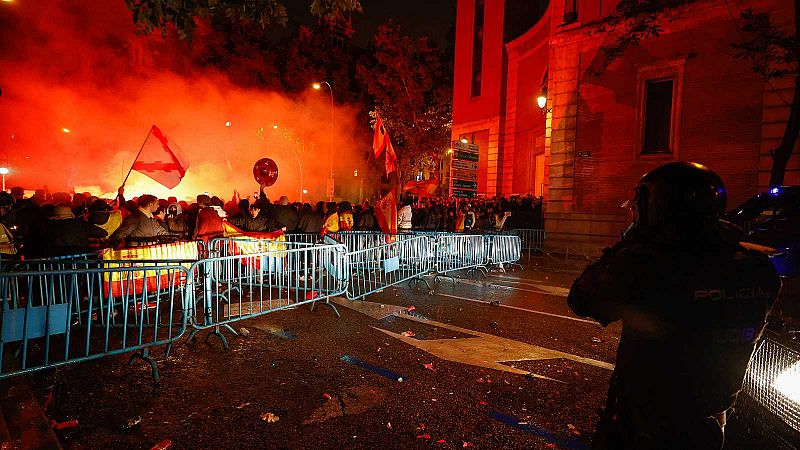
xmin=344 ymin=236 xmax=434 ymax=300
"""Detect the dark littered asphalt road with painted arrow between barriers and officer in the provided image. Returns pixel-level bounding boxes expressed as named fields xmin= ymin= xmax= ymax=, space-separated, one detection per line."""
xmin=28 ymin=260 xmax=620 ymax=449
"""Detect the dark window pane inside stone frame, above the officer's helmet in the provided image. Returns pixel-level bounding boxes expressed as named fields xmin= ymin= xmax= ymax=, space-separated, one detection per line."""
xmin=642 ymin=79 xmax=675 ymax=153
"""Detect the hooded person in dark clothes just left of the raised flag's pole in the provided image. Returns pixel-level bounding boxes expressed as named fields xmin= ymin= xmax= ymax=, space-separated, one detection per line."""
xmin=43 ymin=205 xmax=108 ymax=256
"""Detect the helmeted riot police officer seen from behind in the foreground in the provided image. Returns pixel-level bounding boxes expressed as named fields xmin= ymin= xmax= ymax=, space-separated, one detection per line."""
xmin=568 ymin=162 xmax=780 ymax=449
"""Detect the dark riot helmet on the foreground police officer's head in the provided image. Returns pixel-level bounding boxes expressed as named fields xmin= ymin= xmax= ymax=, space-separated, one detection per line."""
xmin=633 ymin=161 xmax=727 ymax=227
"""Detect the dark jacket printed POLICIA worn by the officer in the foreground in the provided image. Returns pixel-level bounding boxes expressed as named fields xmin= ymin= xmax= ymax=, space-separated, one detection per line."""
xmin=567 ymin=223 xmax=780 ymax=448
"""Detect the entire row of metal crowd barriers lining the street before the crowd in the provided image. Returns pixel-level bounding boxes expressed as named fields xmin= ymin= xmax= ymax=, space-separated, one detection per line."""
xmin=0 ymin=232 xmax=523 ymax=380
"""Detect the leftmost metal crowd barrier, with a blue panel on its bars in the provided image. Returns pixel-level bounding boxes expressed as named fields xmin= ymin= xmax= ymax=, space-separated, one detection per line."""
xmin=0 ymin=265 xmax=192 ymax=381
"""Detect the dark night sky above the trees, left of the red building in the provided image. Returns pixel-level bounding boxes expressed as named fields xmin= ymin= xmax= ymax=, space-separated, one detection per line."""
xmin=284 ymin=0 xmax=456 ymax=47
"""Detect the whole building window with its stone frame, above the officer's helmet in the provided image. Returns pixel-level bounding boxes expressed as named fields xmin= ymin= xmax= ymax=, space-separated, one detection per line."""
xmin=635 ymin=59 xmax=686 ymax=158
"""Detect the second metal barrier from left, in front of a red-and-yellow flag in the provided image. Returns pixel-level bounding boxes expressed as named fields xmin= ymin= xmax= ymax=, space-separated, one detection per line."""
xmin=189 ymin=238 xmax=347 ymax=348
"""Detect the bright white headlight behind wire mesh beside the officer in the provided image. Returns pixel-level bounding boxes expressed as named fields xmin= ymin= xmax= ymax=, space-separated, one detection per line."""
xmin=742 ymin=339 xmax=800 ymax=431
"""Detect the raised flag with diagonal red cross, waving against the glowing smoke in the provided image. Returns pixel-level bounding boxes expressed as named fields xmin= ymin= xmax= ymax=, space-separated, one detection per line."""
xmin=132 ymin=125 xmax=189 ymax=189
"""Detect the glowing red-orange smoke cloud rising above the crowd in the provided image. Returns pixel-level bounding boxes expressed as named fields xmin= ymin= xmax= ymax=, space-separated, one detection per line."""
xmin=0 ymin=0 xmax=369 ymax=200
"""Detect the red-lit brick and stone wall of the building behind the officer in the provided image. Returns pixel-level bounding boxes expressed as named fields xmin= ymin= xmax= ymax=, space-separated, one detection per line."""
xmin=453 ymin=0 xmax=800 ymax=251
